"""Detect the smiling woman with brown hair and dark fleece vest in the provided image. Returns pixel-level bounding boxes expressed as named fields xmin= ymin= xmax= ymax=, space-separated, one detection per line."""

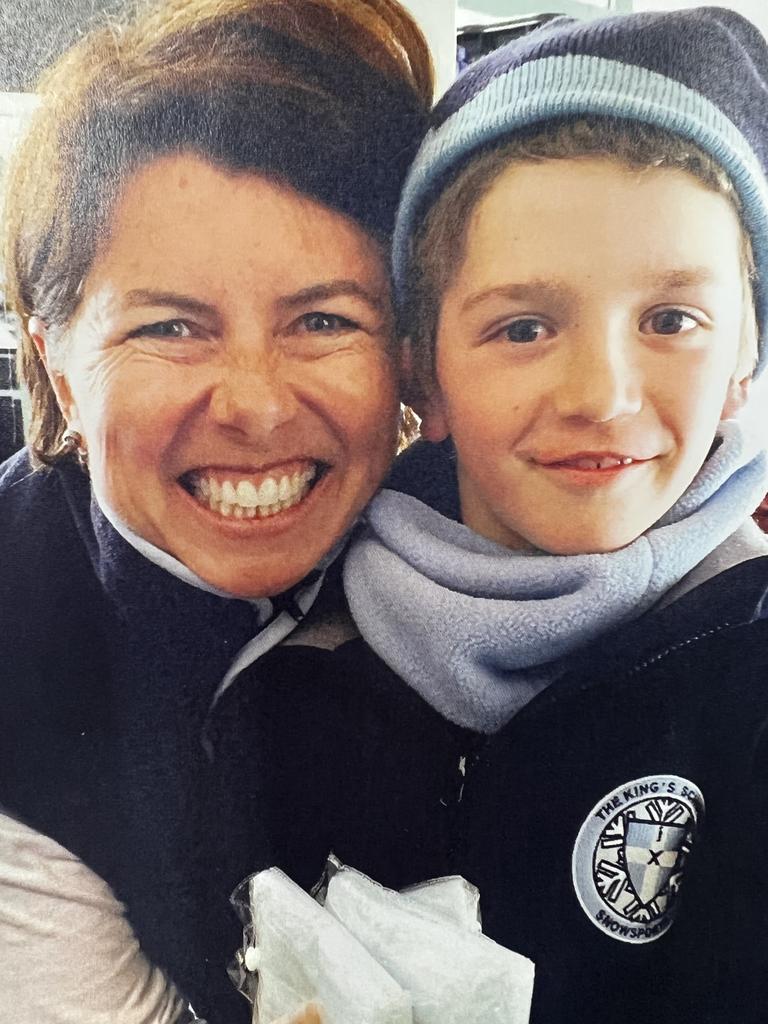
xmin=0 ymin=0 xmax=431 ymax=1024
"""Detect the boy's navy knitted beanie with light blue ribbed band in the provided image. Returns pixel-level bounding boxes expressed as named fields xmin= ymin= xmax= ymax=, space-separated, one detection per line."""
xmin=392 ymin=7 xmax=768 ymax=374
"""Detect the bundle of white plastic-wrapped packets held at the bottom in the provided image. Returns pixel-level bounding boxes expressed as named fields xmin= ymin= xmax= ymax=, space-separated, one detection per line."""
xmin=232 ymin=857 xmax=534 ymax=1024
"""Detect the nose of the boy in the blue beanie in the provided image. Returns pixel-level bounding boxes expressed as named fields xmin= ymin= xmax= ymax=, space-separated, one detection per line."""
xmin=555 ymin=327 xmax=642 ymax=423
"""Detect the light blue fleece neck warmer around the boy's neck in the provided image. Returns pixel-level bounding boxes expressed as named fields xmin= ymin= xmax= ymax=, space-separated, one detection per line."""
xmin=344 ymin=420 xmax=768 ymax=733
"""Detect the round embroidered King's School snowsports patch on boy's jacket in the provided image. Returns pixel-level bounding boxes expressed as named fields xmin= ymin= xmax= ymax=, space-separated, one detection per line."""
xmin=572 ymin=775 xmax=703 ymax=942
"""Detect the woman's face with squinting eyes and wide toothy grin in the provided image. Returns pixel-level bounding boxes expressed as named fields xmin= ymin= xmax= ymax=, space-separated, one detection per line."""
xmin=41 ymin=155 xmax=398 ymax=597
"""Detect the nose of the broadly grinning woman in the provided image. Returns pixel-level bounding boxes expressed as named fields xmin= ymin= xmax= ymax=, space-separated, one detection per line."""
xmin=209 ymin=354 xmax=298 ymax=440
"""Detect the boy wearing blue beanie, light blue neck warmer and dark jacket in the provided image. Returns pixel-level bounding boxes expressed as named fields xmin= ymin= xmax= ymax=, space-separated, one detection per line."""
xmin=345 ymin=8 xmax=768 ymax=1024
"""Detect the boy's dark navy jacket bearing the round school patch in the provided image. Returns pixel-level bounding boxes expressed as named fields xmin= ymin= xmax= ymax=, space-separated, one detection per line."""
xmin=216 ymin=558 xmax=768 ymax=1024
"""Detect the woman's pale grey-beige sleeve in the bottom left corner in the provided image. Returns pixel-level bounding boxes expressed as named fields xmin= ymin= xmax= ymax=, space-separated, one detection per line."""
xmin=0 ymin=812 xmax=184 ymax=1024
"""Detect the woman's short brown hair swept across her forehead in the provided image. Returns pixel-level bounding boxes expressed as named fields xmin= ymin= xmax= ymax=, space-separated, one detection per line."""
xmin=3 ymin=0 xmax=433 ymax=464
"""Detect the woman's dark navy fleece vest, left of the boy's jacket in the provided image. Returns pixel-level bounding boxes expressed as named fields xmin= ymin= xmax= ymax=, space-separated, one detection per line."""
xmin=0 ymin=455 xmax=256 ymax=1024
